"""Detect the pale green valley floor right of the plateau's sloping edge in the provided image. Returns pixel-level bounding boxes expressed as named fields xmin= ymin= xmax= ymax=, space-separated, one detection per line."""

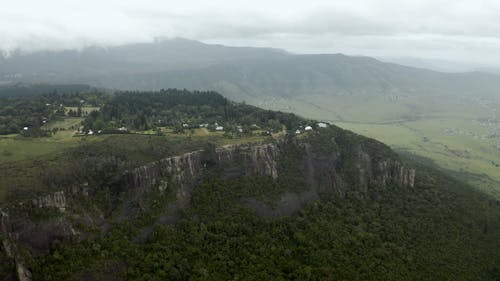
xmin=336 ymin=119 xmax=500 ymax=198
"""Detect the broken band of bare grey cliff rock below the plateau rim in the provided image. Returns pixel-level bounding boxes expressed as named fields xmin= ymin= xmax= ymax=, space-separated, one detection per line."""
xmin=0 ymin=143 xmax=415 ymax=222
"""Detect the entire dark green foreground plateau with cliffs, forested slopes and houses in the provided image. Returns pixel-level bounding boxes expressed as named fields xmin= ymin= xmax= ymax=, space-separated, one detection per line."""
xmin=0 ymin=90 xmax=500 ymax=281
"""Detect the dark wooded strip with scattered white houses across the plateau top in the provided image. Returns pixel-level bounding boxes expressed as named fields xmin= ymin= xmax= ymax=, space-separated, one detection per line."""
xmin=0 ymin=89 xmax=307 ymax=137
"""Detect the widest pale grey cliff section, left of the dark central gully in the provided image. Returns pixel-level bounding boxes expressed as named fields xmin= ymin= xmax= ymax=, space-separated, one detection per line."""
xmin=119 ymin=143 xmax=279 ymax=200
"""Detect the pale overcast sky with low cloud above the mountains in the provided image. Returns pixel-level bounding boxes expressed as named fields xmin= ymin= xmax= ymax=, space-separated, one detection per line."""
xmin=0 ymin=0 xmax=500 ymax=65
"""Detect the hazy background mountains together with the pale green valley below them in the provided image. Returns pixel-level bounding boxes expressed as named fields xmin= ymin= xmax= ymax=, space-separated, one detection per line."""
xmin=0 ymin=39 xmax=500 ymax=197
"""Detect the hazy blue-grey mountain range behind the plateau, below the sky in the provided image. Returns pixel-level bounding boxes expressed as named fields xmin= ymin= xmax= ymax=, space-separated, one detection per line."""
xmin=0 ymin=39 xmax=500 ymax=104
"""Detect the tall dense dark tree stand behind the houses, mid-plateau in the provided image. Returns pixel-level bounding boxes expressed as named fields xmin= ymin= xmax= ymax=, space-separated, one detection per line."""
xmin=84 ymin=89 xmax=304 ymax=131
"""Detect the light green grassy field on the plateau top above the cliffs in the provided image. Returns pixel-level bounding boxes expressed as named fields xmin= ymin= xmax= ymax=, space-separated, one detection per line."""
xmin=0 ymin=118 xmax=274 ymax=202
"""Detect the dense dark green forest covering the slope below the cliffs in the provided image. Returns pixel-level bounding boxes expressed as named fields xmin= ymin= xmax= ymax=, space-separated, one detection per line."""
xmin=28 ymin=162 xmax=500 ymax=281
